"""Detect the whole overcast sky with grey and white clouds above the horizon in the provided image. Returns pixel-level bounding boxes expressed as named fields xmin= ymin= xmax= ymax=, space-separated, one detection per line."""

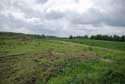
xmin=0 ymin=0 xmax=125 ymax=37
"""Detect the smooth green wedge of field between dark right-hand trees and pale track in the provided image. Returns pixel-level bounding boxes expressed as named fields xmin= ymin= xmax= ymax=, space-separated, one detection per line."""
xmin=64 ymin=39 xmax=125 ymax=51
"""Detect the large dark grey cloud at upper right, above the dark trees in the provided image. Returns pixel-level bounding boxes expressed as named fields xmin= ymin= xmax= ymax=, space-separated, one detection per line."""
xmin=71 ymin=2 xmax=125 ymax=27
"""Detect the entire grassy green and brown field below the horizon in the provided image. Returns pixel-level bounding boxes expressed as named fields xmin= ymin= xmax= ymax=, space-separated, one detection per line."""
xmin=0 ymin=34 xmax=125 ymax=84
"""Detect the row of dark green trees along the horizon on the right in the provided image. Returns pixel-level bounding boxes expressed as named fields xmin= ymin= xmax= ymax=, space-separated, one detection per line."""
xmin=69 ymin=34 xmax=125 ymax=42
